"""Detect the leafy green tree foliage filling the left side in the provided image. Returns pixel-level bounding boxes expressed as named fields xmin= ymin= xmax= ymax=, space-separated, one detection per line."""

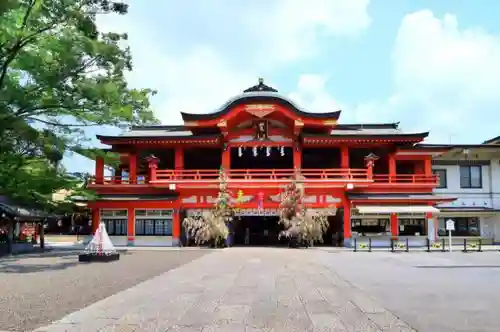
xmin=0 ymin=0 xmax=157 ymax=208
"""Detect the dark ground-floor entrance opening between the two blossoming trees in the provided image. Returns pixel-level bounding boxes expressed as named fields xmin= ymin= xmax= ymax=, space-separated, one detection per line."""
xmin=233 ymin=216 xmax=288 ymax=246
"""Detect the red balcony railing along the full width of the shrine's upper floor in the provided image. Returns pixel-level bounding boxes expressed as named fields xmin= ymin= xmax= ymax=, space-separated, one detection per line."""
xmin=90 ymin=168 xmax=438 ymax=186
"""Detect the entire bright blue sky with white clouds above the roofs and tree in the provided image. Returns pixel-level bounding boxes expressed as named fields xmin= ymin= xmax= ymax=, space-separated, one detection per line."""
xmin=65 ymin=0 xmax=500 ymax=171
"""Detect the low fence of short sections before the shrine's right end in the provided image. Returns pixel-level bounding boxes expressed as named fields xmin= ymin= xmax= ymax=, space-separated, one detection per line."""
xmin=353 ymin=237 xmax=483 ymax=252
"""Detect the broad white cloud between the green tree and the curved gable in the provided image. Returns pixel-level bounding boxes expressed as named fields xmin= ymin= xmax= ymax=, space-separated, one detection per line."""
xmin=99 ymin=0 xmax=370 ymax=124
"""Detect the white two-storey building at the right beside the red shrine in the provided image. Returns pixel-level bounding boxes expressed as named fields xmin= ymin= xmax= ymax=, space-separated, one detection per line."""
xmin=432 ymin=138 xmax=500 ymax=243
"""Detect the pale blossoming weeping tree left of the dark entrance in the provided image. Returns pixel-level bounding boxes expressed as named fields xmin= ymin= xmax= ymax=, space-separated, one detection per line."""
xmin=183 ymin=169 xmax=234 ymax=245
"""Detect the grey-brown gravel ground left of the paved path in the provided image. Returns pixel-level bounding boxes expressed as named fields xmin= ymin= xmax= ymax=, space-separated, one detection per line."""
xmin=0 ymin=250 xmax=209 ymax=331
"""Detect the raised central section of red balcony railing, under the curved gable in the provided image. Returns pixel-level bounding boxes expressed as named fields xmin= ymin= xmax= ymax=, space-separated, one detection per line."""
xmin=152 ymin=168 xmax=367 ymax=182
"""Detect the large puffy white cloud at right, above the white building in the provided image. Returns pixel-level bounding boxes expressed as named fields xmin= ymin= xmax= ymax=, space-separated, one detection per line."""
xmin=295 ymin=10 xmax=500 ymax=143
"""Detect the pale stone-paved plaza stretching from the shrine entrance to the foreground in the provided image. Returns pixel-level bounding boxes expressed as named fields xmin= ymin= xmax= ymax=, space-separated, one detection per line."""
xmin=2 ymin=248 xmax=500 ymax=332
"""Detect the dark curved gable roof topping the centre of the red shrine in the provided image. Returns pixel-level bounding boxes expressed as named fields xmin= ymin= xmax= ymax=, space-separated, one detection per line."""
xmin=181 ymin=79 xmax=341 ymax=121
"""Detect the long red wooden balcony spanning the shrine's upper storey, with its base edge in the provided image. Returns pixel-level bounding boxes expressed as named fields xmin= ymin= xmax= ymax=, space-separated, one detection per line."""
xmin=89 ymin=168 xmax=438 ymax=188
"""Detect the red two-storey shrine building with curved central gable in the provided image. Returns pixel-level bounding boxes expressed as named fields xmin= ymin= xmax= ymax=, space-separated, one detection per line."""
xmin=89 ymin=79 xmax=454 ymax=246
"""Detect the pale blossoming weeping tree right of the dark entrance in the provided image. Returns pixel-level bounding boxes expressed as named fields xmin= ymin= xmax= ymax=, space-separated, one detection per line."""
xmin=279 ymin=174 xmax=332 ymax=243
